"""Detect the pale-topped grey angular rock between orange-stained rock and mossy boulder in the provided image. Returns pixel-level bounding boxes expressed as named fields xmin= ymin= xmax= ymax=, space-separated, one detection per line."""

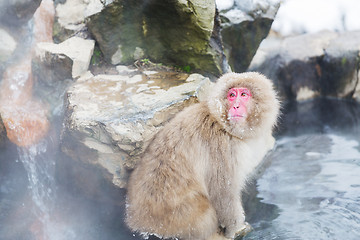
xmin=32 ymin=37 xmax=95 ymax=116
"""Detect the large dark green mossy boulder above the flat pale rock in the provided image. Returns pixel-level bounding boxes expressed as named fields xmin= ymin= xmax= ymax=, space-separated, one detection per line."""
xmin=87 ymin=0 xmax=224 ymax=75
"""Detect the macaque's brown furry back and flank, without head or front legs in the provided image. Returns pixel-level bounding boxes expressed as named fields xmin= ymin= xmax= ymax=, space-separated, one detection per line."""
xmin=127 ymin=103 xmax=222 ymax=237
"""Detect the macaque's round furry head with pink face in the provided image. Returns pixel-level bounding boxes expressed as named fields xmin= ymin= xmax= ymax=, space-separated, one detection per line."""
xmin=208 ymin=72 xmax=280 ymax=139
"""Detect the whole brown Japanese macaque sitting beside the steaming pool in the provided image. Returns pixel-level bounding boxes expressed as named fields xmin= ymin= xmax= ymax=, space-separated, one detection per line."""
xmin=126 ymin=72 xmax=280 ymax=240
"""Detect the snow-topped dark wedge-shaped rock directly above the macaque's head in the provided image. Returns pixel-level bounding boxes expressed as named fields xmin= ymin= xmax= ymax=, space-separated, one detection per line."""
xmin=220 ymin=0 xmax=280 ymax=72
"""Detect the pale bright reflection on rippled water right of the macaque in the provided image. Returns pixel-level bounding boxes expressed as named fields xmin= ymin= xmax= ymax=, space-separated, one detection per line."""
xmin=246 ymin=134 xmax=360 ymax=239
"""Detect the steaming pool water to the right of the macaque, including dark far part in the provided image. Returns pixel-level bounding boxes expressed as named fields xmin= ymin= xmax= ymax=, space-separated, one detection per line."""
xmin=244 ymin=100 xmax=360 ymax=240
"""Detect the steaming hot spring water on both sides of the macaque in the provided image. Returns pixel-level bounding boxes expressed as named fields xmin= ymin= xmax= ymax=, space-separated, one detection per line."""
xmin=0 ymin=97 xmax=360 ymax=240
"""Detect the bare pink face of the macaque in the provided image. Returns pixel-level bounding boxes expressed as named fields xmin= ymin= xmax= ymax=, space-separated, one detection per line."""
xmin=227 ymin=88 xmax=252 ymax=121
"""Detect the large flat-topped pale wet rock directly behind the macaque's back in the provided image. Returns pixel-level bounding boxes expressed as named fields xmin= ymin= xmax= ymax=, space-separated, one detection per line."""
xmin=62 ymin=66 xmax=209 ymax=187
